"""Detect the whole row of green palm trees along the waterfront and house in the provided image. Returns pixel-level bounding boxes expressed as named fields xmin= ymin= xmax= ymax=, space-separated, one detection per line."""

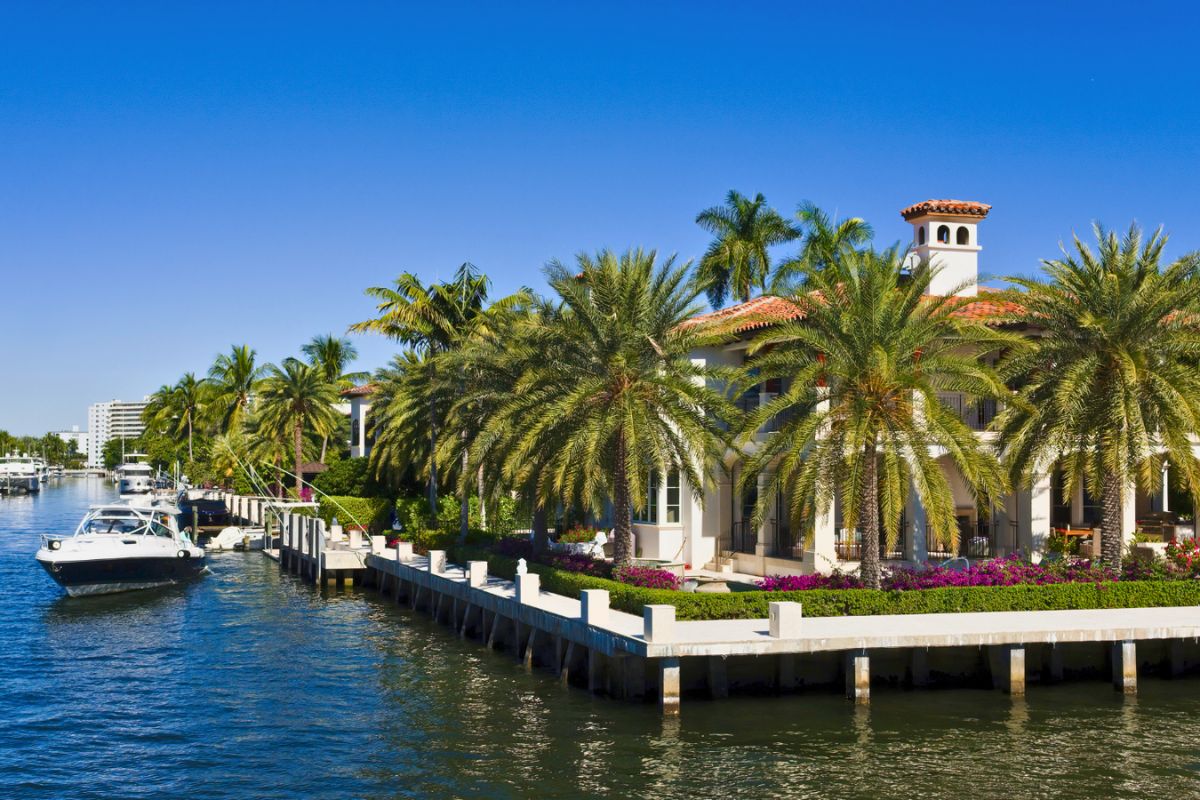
xmin=146 ymin=192 xmax=1200 ymax=585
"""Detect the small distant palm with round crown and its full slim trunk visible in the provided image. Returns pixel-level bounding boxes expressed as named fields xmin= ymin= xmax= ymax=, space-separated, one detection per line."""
xmin=258 ymin=359 xmax=337 ymax=495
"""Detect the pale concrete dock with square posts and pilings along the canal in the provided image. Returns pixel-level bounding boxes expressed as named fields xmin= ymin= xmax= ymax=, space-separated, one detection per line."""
xmin=220 ymin=498 xmax=1200 ymax=714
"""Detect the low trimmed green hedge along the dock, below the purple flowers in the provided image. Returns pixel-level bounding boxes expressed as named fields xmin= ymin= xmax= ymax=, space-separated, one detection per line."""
xmin=451 ymin=547 xmax=1200 ymax=620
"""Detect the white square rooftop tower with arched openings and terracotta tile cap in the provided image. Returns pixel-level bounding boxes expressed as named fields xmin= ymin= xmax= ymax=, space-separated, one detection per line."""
xmin=900 ymin=200 xmax=991 ymax=295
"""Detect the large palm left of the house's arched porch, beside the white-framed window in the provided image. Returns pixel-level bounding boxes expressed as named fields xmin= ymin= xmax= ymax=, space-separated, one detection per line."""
xmin=477 ymin=249 xmax=732 ymax=565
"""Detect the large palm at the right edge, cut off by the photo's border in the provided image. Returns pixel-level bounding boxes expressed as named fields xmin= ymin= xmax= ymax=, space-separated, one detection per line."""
xmin=997 ymin=223 xmax=1200 ymax=565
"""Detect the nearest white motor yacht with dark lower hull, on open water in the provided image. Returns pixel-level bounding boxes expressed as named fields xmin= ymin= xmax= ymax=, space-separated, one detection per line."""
xmin=36 ymin=501 xmax=204 ymax=597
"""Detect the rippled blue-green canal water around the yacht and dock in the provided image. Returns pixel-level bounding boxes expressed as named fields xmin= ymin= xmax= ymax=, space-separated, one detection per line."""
xmin=0 ymin=479 xmax=1200 ymax=800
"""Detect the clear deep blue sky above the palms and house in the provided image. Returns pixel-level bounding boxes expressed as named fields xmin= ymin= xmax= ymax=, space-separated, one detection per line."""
xmin=0 ymin=0 xmax=1200 ymax=433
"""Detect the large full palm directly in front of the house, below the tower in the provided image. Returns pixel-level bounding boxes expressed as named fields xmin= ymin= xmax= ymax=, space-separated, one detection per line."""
xmin=742 ymin=248 xmax=1020 ymax=588
